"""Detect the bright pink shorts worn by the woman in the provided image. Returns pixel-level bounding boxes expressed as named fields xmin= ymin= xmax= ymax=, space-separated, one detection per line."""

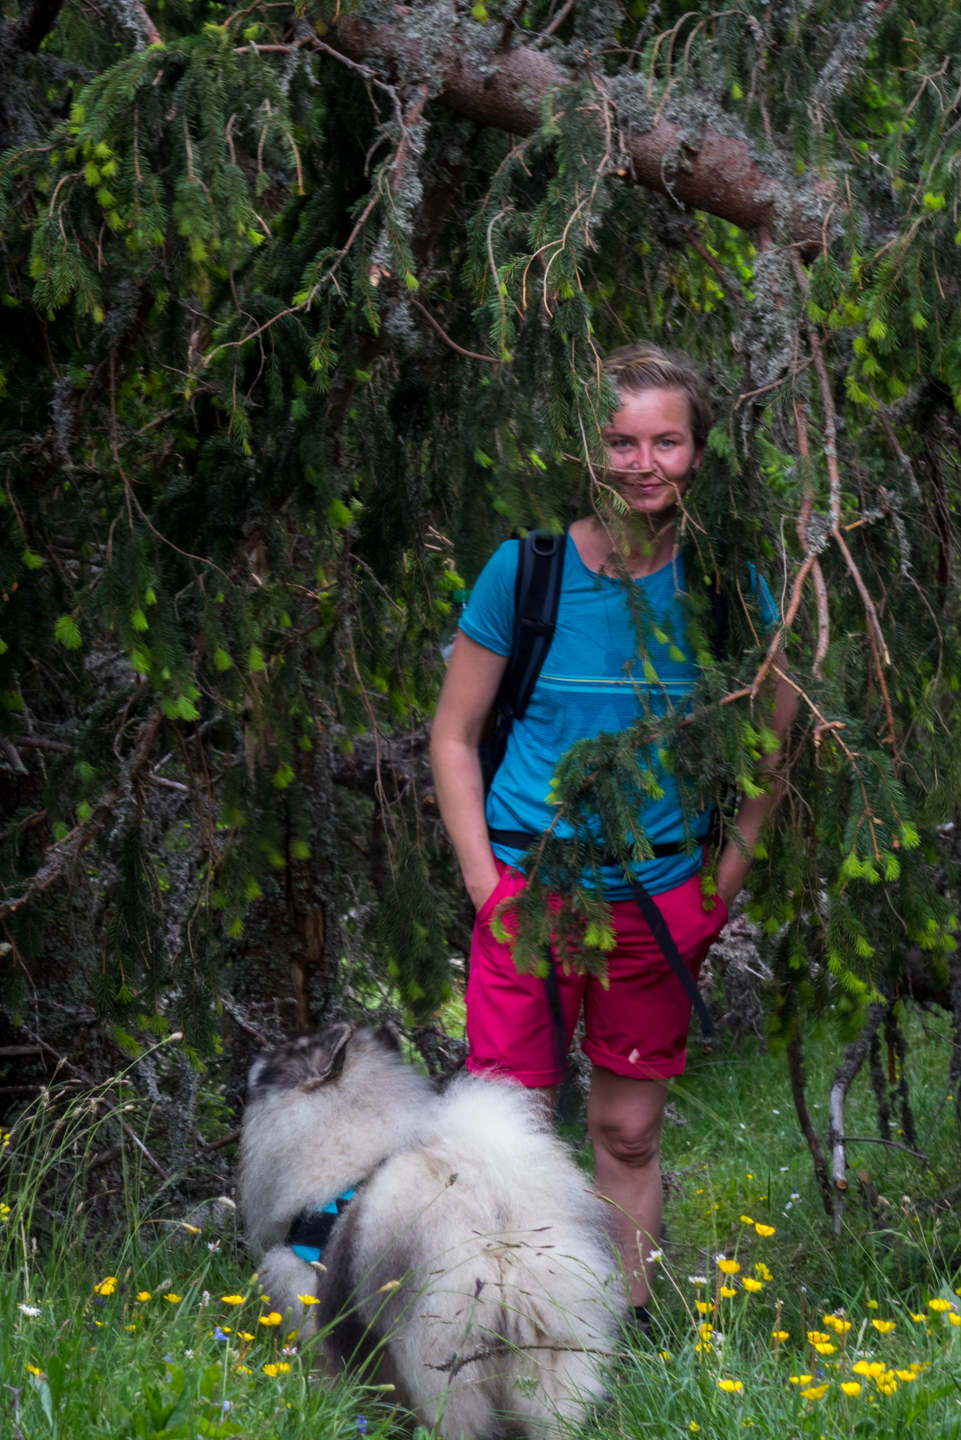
xmin=467 ymin=860 xmax=728 ymax=1087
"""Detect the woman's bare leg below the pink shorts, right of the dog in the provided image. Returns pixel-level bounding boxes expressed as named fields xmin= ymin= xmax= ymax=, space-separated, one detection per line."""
xmin=588 ymin=1064 xmax=667 ymax=1305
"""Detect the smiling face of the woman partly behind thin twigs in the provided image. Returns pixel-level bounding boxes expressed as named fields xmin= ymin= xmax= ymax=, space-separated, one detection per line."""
xmin=602 ymin=389 xmax=703 ymax=517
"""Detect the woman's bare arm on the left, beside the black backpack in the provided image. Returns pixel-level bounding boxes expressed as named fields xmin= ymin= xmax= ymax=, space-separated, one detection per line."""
xmin=431 ymin=631 xmax=507 ymax=910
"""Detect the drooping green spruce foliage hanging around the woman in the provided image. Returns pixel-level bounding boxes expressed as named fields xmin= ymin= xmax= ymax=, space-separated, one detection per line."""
xmin=0 ymin=0 xmax=961 ymax=1054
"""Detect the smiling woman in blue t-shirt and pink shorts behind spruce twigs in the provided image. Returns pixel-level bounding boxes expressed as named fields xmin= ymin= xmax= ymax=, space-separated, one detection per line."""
xmin=431 ymin=344 xmax=794 ymax=1322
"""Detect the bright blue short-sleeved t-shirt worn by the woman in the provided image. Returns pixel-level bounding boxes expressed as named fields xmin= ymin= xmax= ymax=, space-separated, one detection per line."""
xmin=461 ymin=536 xmax=777 ymax=900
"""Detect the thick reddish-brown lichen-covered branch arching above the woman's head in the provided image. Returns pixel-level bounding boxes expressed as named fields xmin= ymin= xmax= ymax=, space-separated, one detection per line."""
xmin=324 ymin=17 xmax=823 ymax=246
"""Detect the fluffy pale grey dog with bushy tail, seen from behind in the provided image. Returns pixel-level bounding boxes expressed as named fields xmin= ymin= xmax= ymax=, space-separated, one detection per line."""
xmin=241 ymin=1025 xmax=624 ymax=1440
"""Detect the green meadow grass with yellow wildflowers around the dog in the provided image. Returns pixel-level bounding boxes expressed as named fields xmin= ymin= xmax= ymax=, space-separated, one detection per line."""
xmin=0 ymin=1017 xmax=961 ymax=1440
